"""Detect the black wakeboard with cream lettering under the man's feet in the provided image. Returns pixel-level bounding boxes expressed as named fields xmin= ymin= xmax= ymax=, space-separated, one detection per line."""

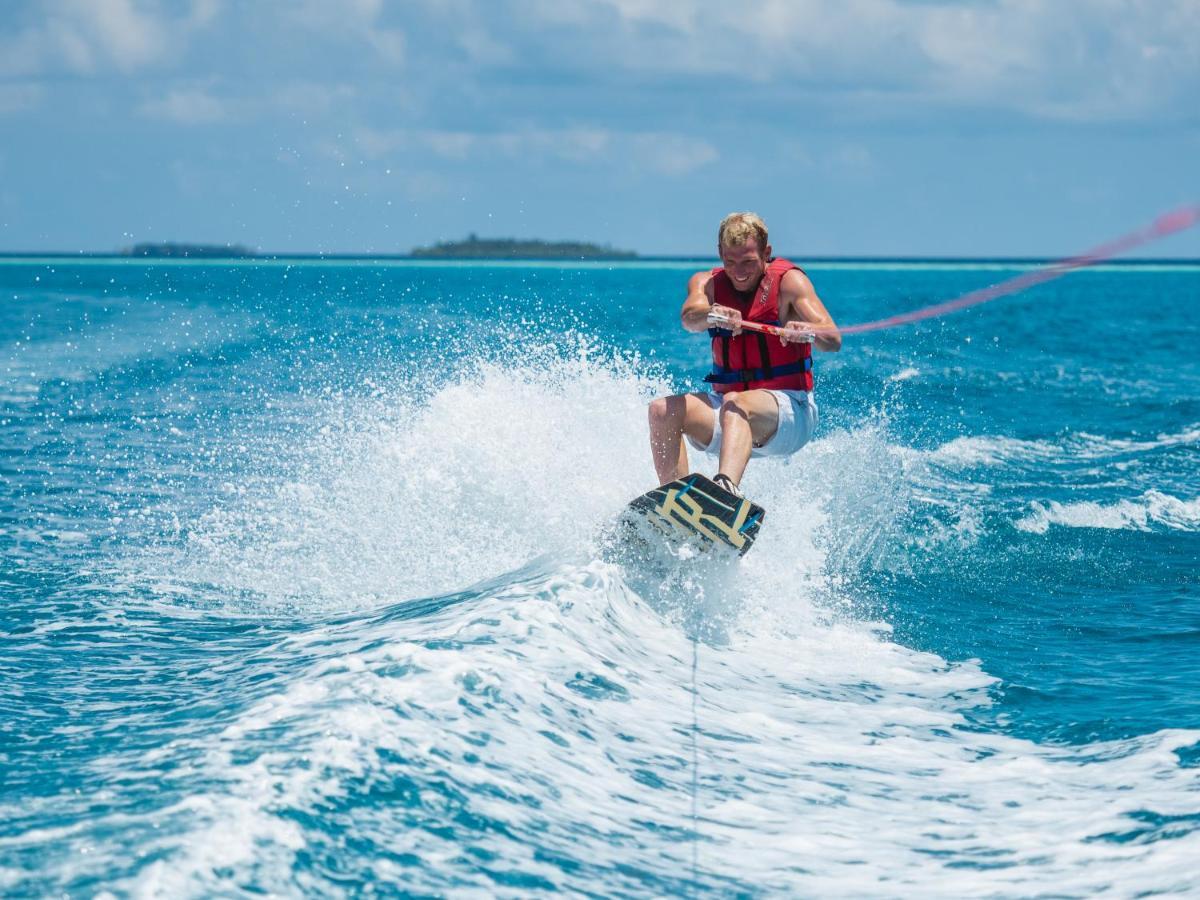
xmin=620 ymin=472 xmax=763 ymax=556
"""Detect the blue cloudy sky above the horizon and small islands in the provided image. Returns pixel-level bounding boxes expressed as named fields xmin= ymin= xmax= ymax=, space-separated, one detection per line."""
xmin=0 ymin=0 xmax=1200 ymax=258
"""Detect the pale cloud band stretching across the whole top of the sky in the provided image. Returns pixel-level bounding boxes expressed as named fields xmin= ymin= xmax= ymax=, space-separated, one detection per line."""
xmin=0 ymin=0 xmax=1200 ymax=138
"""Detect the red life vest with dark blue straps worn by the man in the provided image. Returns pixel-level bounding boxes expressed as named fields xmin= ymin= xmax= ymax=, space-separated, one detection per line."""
xmin=704 ymin=259 xmax=812 ymax=394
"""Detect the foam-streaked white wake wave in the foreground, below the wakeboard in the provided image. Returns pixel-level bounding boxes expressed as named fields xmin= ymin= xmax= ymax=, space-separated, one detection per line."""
xmin=32 ymin=562 xmax=1200 ymax=896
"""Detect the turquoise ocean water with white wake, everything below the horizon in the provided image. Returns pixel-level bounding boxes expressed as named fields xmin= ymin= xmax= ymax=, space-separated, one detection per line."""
xmin=0 ymin=259 xmax=1200 ymax=898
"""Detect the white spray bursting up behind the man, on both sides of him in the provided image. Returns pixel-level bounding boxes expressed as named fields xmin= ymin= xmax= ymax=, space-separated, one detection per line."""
xmin=134 ymin=342 xmax=936 ymax=611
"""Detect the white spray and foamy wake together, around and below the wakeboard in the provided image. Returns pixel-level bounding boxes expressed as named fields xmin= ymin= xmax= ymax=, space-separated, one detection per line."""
xmin=60 ymin=354 xmax=1200 ymax=896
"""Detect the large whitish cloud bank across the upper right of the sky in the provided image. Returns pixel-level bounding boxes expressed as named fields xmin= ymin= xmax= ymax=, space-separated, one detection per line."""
xmin=511 ymin=0 xmax=1200 ymax=120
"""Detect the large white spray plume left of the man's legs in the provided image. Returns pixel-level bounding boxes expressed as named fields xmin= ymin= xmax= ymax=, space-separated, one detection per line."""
xmin=144 ymin=343 xmax=666 ymax=608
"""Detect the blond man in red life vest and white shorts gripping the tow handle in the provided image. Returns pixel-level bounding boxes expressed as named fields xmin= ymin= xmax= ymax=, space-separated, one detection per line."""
xmin=649 ymin=212 xmax=841 ymax=497
